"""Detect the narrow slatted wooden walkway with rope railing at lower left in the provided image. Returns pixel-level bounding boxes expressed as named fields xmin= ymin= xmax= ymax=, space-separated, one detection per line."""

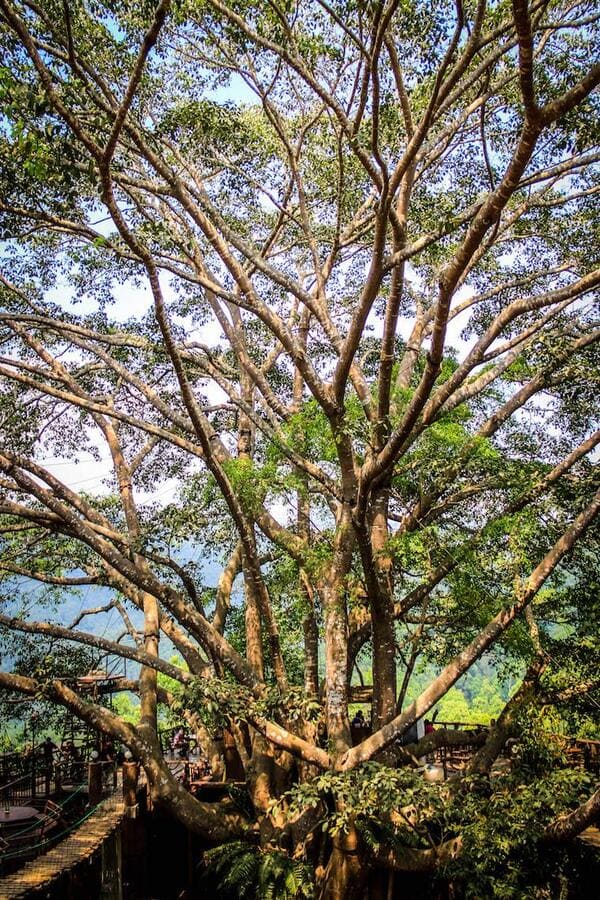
xmin=0 ymin=795 xmax=125 ymax=900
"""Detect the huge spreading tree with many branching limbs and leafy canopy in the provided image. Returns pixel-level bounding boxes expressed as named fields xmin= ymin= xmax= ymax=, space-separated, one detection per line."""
xmin=0 ymin=0 xmax=600 ymax=898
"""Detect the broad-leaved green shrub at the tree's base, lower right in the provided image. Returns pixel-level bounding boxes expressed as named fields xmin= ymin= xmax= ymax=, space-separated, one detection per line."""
xmin=274 ymin=760 xmax=594 ymax=900
